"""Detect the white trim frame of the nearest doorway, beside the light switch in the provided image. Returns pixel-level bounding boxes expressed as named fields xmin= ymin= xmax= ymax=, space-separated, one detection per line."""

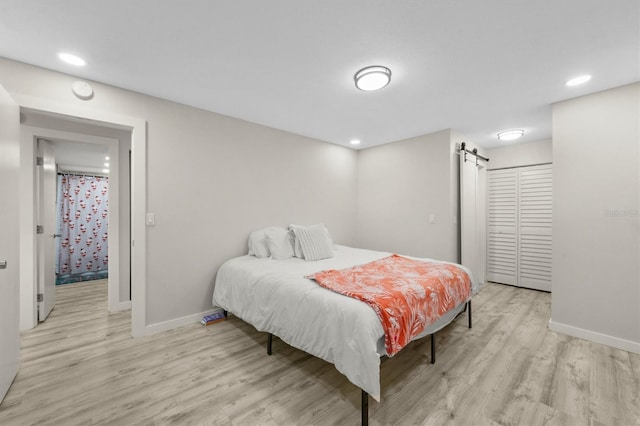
xmin=14 ymin=95 xmax=147 ymax=337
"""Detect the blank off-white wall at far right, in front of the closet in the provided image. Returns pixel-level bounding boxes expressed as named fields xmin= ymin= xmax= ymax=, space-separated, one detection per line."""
xmin=550 ymin=83 xmax=640 ymax=352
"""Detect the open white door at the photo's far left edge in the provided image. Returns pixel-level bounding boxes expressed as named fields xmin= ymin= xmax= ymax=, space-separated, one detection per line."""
xmin=0 ymin=86 xmax=20 ymax=402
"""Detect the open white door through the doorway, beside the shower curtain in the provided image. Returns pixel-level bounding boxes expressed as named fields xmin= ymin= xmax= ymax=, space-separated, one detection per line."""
xmin=36 ymin=139 xmax=58 ymax=321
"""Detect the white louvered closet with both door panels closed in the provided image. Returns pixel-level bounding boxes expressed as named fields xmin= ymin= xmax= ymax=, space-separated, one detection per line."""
xmin=487 ymin=164 xmax=553 ymax=291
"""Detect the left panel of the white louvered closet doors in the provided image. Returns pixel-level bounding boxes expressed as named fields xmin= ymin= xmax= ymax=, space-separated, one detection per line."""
xmin=487 ymin=169 xmax=518 ymax=285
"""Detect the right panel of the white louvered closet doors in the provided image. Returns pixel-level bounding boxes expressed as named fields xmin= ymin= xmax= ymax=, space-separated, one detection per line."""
xmin=518 ymin=164 xmax=553 ymax=291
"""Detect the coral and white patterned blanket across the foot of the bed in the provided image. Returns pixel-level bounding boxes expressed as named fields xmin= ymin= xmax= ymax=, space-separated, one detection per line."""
xmin=308 ymin=254 xmax=471 ymax=356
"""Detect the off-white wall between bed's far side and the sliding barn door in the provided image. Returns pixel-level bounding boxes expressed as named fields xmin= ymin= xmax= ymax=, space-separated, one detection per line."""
xmin=357 ymin=130 xmax=458 ymax=261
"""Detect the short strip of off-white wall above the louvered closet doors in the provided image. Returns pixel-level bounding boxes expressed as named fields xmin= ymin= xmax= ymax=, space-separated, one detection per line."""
xmin=487 ymin=139 xmax=553 ymax=170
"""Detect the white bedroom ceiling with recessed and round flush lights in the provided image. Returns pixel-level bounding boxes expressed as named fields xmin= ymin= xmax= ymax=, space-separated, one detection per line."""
xmin=0 ymin=0 xmax=640 ymax=148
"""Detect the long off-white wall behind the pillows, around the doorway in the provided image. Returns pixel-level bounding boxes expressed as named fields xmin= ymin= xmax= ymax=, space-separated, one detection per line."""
xmin=0 ymin=59 xmax=357 ymax=325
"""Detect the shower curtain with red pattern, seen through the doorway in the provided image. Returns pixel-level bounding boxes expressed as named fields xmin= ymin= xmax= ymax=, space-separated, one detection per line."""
xmin=56 ymin=174 xmax=109 ymax=284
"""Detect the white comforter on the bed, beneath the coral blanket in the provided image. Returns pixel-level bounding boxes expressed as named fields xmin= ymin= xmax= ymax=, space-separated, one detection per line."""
xmin=213 ymin=245 xmax=477 ymax=401
